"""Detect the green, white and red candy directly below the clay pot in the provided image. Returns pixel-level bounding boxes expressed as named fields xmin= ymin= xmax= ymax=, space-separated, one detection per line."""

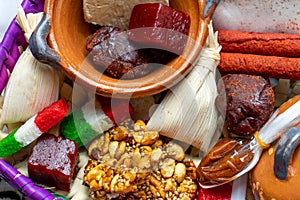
xmin=60 ymin=97 xmax=133 ymax=147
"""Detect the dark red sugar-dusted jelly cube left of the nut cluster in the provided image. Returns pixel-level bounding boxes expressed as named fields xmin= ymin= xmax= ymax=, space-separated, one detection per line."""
xmin=28 ymin=133 xmax=79 ymax=191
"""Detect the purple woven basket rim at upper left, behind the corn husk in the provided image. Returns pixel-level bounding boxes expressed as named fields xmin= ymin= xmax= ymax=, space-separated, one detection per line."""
xmin=0 ymin=0 xmax=45 ymax=94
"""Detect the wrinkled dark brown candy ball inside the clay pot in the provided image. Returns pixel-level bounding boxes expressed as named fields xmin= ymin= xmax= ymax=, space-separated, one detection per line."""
xmin=86 ymin=26 xmax=151 ymax=79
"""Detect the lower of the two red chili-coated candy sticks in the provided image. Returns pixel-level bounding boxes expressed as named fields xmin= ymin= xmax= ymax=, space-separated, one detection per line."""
xmin=218 ymin=52 xmax=300 ymax=80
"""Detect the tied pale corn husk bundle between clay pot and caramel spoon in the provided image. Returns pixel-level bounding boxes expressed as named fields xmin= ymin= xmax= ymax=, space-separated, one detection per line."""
xmin=147 ymin=21 xmax=221 ymax=152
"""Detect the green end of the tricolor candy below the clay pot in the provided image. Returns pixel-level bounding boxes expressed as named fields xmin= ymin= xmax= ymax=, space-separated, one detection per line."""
xmin=60 ymin=110 xmax=99 ymax=147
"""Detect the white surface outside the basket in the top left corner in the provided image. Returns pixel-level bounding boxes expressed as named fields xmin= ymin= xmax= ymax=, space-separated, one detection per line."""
xmin=0 ymin=0 xmax=22 ymax=41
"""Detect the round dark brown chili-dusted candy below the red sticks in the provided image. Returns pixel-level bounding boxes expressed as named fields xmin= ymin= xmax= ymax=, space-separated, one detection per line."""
xmin=216 ymin=74 xmax=274 ymax=136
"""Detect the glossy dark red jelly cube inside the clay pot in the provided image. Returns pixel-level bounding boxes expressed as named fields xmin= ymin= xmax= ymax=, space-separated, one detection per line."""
xmin=129 ymin=3 xmax=190 ymax=55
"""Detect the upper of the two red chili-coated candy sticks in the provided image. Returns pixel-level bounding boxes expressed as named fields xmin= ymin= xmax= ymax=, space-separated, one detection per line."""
xmin=218 ymin=30 xmax=300 ymax=57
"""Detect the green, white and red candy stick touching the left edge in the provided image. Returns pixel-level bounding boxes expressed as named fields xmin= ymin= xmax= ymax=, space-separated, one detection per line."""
xmin=0 ymin=99 xmax=68 ymax=157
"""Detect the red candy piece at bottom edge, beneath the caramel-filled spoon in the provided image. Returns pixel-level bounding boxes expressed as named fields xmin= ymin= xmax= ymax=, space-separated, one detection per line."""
xmin=198 ymin=184 xmax=232 ymax=200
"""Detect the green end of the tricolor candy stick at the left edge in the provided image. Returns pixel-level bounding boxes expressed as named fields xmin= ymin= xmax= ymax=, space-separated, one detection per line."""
xmin=0 ymin=129 xmax=23 ymax=157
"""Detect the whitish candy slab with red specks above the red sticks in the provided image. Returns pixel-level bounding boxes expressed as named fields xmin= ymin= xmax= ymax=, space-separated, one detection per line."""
xmin=212 ymin=0 xmax=300 ymax=34
